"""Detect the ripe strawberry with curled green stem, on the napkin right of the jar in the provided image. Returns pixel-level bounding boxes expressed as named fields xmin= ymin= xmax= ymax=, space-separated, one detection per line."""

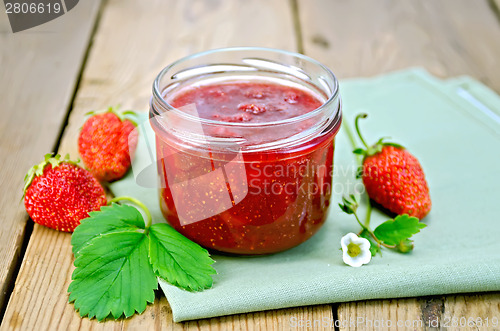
xmin=354 ymin=114 xmax=432 ymax=219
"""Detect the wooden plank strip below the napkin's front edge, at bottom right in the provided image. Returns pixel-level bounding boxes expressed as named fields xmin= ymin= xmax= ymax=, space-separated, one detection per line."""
xmin=338 ymin=292 xmax=500 ymax=330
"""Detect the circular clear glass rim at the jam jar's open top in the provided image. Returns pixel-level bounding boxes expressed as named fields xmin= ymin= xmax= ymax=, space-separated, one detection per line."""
xmin=153 ymin=47 xmax=340 ymax=128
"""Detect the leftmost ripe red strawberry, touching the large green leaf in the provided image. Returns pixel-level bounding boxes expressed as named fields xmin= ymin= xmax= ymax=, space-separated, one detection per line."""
xmin=24 ymin=154 xmax=106 ymax=232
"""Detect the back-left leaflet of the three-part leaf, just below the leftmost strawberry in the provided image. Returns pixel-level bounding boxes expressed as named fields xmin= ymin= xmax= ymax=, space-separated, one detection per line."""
xmin=71 ymin=203 xmax=144 ymax=255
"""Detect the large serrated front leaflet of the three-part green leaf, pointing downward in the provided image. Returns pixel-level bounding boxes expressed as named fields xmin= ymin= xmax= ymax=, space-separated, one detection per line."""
xmin=68 ymin=231 xmax=158 ymax=321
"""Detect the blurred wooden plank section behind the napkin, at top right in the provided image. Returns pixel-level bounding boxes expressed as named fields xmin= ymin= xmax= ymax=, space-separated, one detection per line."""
xmin=298 ymin=0 xmax=500 ymax=92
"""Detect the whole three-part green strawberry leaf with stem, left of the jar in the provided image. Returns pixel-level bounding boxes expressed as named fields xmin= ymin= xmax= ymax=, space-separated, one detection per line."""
xmin=68 ymin=197 xmax=216 ymax=321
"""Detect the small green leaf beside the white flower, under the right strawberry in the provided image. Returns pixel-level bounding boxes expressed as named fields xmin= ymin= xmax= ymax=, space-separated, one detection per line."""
xmin=373 ymin=214 xmax=426 ymax=245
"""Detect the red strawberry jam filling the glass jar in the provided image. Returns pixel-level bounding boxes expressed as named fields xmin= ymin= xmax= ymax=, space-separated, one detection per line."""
xmin=157 ymin=82 xmax=336 ymax=254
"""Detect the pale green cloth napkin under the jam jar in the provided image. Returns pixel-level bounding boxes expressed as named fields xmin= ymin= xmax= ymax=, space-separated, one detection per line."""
xmin=111 ymin=69 xmax=500 ymax=322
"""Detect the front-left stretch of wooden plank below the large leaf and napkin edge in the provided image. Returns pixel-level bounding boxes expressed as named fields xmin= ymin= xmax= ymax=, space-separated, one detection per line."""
xmin=0 ymin=226 xmax=332 ymax=331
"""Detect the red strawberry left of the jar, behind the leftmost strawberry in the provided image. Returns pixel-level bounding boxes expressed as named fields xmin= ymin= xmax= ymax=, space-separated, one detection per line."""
xmin=78 ymin=107 xmax=137 ymax=182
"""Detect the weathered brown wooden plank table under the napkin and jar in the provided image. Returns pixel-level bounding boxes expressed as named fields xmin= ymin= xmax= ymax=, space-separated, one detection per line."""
xmin=0 ymin=0 xmax=500 ymax=330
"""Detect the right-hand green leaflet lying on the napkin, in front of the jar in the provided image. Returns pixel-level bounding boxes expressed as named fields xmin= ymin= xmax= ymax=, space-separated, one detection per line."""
xmin=149 ymin=223 xmax=216 ymax=291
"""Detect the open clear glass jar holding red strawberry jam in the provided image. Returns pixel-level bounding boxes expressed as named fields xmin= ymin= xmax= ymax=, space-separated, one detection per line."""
xmin=150 ymin=47 xmax=342 ymax=254
